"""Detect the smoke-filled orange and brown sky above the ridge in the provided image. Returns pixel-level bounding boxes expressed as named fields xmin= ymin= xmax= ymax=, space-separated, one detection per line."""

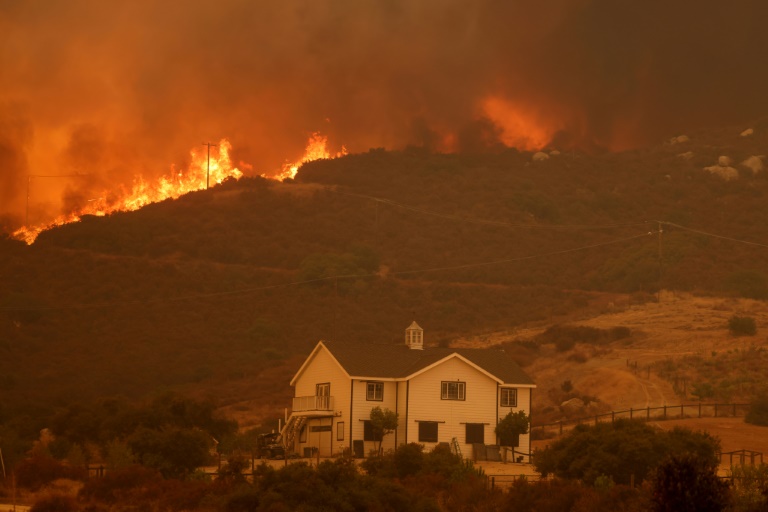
xmin=0 ymin=0 xmax=768 ymax=224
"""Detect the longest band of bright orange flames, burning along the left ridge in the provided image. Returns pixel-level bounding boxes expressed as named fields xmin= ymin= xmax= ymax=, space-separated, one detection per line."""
xmin=12 ymin=139 xmax=243 ymax=244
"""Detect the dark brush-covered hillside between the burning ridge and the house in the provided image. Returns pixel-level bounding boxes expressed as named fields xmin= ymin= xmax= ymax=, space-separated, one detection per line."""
xmin=0 ymin=126 xmax=768 ymax=430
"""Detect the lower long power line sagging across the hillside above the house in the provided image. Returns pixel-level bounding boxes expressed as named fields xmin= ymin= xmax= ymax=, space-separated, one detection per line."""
xmin=0 ymin=232 xmax=654 ymax=311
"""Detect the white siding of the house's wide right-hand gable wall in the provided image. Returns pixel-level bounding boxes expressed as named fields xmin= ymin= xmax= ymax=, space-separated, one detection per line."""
xmin=407 ymin=357 xmax=497 ymax=457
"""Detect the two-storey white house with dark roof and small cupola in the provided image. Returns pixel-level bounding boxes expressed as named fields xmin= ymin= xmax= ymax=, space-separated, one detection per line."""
xmin=282 ymin=322 xmax=536 ymax=457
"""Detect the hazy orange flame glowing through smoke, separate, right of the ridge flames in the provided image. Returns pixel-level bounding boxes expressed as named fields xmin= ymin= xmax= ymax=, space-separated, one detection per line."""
xmin=481 ymin=96 xmax=563 ymax=151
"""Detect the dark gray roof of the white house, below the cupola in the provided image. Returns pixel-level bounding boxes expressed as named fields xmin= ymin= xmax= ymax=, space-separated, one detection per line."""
xmin=323 ymin=341 xmax=533 ymax=384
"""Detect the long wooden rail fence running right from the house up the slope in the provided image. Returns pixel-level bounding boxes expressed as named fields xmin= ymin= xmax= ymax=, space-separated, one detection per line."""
xmin=531 ymin=402 xmax=750 ymax=434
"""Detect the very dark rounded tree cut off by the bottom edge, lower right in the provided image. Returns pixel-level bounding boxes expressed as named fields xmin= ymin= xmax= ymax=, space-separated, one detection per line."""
xmin=651 ymin=453 xmax=729 ymax=512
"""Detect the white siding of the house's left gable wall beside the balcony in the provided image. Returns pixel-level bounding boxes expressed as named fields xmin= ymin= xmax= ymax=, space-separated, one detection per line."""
xmin=294 ymin=348 xmax=351 ymax=457
